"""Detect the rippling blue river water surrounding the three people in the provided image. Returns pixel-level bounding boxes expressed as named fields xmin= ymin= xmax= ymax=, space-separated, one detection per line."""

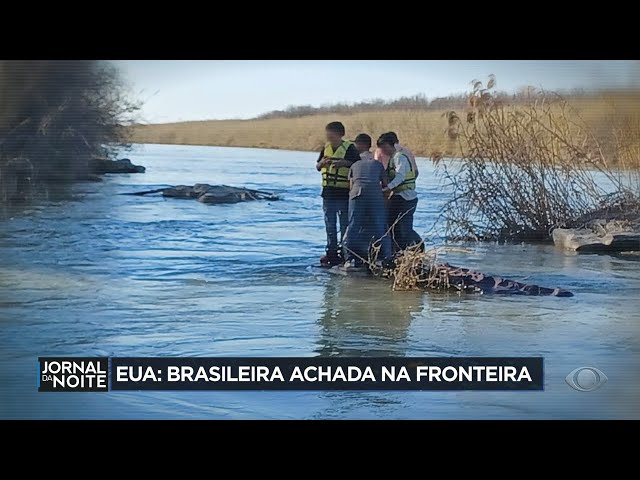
xmin=0 ymin=145 xmax=640 ymax=419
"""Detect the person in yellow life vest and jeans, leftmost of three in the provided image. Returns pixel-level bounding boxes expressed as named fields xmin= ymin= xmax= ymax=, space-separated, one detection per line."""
xmin=316 ymin=122 xmax=360 ymax=265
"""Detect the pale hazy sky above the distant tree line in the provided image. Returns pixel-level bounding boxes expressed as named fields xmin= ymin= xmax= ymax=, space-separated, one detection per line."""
xmin=115 ymin=60 xmax=640 ymax=122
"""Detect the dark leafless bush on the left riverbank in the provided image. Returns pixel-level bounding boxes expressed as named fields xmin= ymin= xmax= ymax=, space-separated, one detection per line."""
xmin=0 ymin=60 xmax=139 ymax=201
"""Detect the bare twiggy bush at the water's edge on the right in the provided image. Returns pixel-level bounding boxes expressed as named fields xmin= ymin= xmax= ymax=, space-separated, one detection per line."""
xmin=436 ymin=77 xmax=640 ymax=240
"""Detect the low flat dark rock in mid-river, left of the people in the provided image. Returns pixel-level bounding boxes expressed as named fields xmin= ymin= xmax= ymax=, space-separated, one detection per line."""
xmin=129 ymin=183 xmax=280 ymax=205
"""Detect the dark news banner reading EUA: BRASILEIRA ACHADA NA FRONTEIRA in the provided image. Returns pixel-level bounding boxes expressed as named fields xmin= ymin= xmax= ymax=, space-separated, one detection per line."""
xmin=38 ymin=357 xmax=544 ymax=392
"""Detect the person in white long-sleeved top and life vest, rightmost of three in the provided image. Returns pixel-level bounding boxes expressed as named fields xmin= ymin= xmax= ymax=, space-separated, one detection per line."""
xmin=377 ymin=133 xmax=422 ymax=251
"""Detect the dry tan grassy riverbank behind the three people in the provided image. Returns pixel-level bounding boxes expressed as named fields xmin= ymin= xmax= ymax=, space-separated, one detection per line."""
xmin=130 ymin=93 xmax=640 ymax=162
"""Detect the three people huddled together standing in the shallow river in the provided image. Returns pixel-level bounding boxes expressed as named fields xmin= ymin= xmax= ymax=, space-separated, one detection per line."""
xmin=316 ymin=122 xmax=421 ymax=267
